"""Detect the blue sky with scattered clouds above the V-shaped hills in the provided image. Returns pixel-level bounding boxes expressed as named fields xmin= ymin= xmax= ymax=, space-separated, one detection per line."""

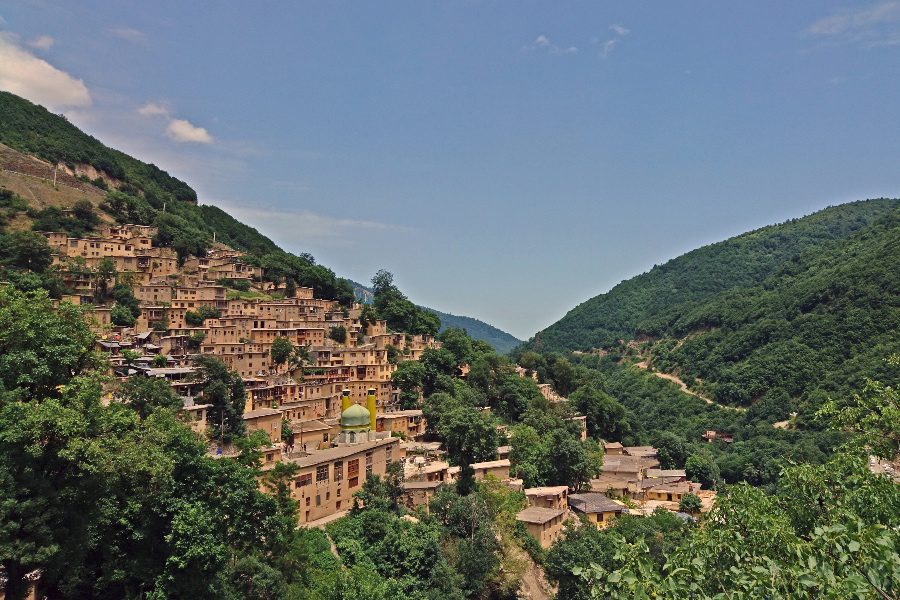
xmin=0 ymin=0 xmax=900 ymax=338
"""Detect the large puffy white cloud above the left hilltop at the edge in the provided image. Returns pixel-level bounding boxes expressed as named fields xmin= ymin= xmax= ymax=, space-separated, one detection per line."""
xmin=0 ymin=33 xmax=91 ymax=110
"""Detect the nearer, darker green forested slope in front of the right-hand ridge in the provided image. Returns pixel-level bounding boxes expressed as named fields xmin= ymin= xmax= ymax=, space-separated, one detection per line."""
xmin=648 ymin=210 xmax=900 ymax=414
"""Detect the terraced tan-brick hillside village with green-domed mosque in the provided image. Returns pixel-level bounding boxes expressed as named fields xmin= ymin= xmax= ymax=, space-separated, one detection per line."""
xmin=35 ymin=217 xmax=715 ymax=536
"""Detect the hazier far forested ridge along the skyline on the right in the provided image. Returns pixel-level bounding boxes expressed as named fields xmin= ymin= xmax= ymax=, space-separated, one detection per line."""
xmin=526 ymin=199 xmax=900 ymax=351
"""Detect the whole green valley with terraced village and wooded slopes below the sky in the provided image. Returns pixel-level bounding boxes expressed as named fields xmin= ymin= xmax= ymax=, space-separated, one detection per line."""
xmin=0 ymin=92 xmax=900 ymax=600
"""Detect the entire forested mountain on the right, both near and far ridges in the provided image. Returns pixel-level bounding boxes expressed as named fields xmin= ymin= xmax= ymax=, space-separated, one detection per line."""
xmin=523 ymin=199 xmax=900 ymax=413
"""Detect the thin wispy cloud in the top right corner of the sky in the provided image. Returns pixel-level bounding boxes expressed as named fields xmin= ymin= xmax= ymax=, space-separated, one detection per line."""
xmin=805 ymin=0 xmax=900 ymax=47
